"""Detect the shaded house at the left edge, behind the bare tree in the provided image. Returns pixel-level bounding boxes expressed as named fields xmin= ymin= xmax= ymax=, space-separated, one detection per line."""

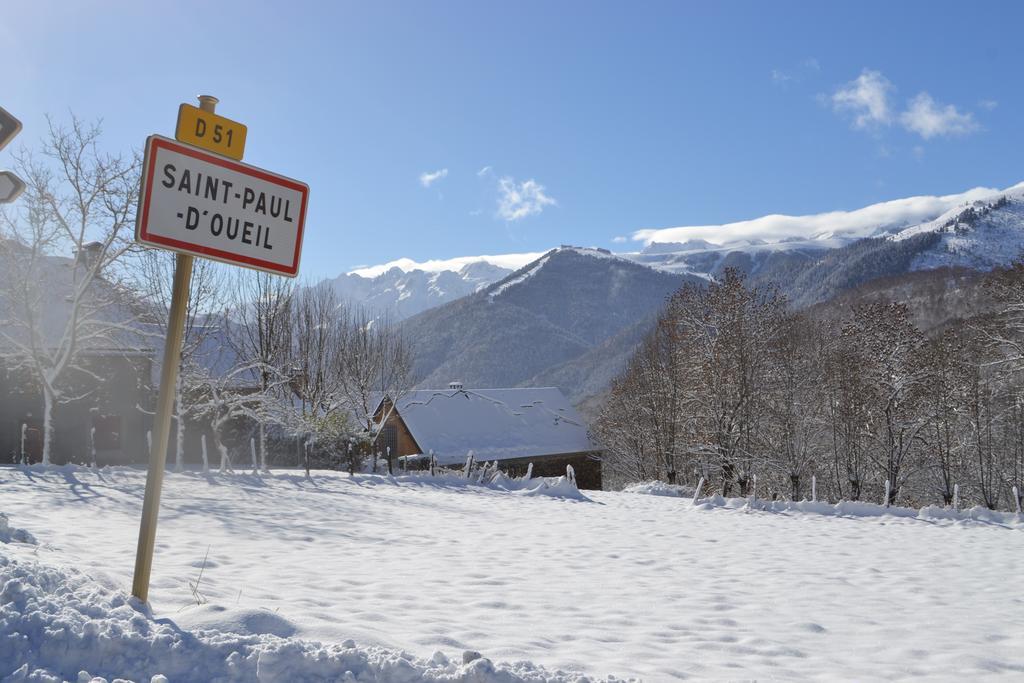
xmin=0 ymin=240 xmax=154 ymax=465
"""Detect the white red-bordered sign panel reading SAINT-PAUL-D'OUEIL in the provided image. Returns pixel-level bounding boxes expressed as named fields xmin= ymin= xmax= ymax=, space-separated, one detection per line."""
xmin=135 ymin=135 xmax=309 ymax=278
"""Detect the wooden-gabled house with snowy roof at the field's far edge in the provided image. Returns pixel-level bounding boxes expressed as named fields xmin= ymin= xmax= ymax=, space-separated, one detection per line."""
xmin=374 ymin=382 xmax=601 ymax=488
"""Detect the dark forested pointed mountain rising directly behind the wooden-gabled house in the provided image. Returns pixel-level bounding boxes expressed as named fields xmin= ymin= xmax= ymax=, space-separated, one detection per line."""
xmin=404 ymin=247 xmax=694 ymax=398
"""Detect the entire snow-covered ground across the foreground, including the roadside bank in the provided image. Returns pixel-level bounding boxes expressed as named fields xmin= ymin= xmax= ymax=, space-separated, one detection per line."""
xmin=0 ymin=468 xmax=1024 ymax=681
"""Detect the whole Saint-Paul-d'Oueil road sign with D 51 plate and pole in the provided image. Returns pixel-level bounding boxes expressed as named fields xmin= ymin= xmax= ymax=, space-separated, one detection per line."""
xmin=131 ymin=95 xmax=309 ymax=602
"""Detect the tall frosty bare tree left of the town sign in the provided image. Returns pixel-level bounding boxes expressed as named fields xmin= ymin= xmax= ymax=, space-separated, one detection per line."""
xmin=0 ymin=116 xmax=140 ymax=464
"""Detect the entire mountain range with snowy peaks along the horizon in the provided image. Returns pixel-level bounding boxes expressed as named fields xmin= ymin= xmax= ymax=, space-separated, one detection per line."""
xmin=317 ymin=183 xmax=1024 ymax=403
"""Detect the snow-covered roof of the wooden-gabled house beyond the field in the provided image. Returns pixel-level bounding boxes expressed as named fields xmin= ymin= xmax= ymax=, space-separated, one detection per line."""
xmin=396 ymin=387 xmax=596 ymax=465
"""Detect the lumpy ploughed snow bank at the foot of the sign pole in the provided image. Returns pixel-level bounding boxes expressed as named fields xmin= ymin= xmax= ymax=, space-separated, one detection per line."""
xmin=0 ymin=517 xmax=614 ymax=683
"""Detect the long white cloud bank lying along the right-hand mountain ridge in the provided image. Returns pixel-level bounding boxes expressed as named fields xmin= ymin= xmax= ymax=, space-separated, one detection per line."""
xmin=633 ymin=183 xmax=1024 ymax=245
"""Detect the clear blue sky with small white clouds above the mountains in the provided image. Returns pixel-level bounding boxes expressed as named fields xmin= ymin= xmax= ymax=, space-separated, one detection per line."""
xmin=0 ymin=0 xmax=1024 ymax=278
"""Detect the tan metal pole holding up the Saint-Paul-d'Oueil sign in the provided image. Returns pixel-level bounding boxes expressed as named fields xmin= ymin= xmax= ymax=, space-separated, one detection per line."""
xmin=131 ymin=95 xmax=217 ymax=602
